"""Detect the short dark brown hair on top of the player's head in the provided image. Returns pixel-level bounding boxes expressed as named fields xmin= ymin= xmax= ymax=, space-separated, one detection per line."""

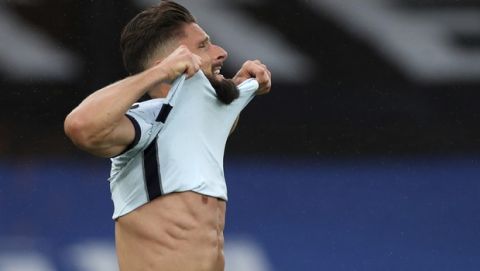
xmin=120 ymin=0 xmax=196 ymax=74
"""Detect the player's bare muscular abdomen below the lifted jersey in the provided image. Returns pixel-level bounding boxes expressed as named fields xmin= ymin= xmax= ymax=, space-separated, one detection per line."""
xmin=115 ymin=192 xmax=226 ymax=271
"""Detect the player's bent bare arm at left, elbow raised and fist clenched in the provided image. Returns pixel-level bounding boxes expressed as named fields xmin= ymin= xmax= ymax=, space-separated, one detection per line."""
xmin=64 ymin=45 xmax=201 ymax=157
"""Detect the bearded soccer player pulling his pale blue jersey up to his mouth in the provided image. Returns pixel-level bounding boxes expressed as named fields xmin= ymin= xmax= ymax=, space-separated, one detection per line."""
xmin=65 ymin=1 xmax=271 ymax=271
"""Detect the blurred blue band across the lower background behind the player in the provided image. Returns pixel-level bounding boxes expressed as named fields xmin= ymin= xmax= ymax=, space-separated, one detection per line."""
xmin=0 ymin=158 xmax=480 ymax=271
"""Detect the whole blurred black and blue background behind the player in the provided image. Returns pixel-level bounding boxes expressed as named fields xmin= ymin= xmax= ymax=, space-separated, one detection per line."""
xmin=0 ymin=0 xmax=480 ymax=271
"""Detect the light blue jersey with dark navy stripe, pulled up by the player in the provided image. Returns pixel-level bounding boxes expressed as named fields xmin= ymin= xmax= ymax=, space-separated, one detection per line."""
xmin=109 ymin=71 xmax=258 ymax=219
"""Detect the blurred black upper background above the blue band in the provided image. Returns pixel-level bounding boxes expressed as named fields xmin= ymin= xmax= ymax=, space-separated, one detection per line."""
xmin=0 ymin=0 xmax=480 ymax=157
